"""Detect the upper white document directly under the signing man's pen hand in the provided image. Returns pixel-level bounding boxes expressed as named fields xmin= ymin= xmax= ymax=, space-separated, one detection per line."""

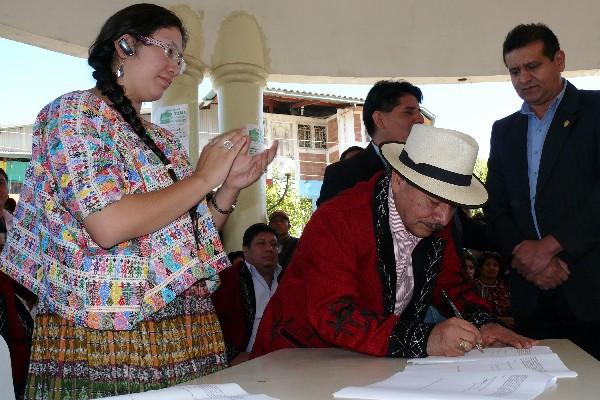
xmin=404 ymin=353 xmax=577 ymax=378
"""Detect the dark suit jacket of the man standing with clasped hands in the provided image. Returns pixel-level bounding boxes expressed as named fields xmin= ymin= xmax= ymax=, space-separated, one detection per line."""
xmin=485 ymin=83 xmax=600 ymax=320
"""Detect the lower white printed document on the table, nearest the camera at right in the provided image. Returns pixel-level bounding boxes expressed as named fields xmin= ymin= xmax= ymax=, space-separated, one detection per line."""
xmin=333 ymin=371 xmax=556 ymax=400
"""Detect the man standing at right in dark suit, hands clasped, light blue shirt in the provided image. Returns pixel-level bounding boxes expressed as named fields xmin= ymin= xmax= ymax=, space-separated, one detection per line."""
xmin=485 ymin=24 xmax=600 ymax=359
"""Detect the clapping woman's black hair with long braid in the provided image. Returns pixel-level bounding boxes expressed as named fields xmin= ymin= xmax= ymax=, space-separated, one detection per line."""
xmin=88 ymin=3 xmax=187 ymax=170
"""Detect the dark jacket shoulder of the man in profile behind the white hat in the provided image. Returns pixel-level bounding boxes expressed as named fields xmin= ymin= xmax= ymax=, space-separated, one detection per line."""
xmin=317 ymin=143 xmax=385 ymax=207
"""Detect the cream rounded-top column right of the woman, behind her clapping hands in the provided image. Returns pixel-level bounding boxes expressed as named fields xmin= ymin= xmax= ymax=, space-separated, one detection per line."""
xmin=211 ymin=12 xmax=268 ymax=251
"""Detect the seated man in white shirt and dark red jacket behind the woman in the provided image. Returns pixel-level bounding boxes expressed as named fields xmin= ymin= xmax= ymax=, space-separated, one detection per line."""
xmin=212 ymin=223 xmax=281 ymax=365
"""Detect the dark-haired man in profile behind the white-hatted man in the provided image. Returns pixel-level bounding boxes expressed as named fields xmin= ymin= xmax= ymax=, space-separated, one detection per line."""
xmin=317 ymin=81 xmax=424 ymax=206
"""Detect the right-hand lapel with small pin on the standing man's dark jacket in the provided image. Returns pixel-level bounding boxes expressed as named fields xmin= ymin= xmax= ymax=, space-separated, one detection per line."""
xmin=536 ymin=83 xmax=579 ymax=195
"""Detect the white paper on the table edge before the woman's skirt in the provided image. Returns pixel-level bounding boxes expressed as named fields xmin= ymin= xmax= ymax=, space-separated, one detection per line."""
xmin=99 ymin=383 xmax=277 ymax=400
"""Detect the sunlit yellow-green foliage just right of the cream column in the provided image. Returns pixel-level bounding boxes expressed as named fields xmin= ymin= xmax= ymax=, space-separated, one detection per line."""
xmin=265 ymin=178 xmax=312 ymax=237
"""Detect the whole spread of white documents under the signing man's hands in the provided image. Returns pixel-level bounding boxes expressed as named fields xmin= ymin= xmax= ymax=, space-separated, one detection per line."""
xmin=333 ymin=346 xmax=577 ymax=400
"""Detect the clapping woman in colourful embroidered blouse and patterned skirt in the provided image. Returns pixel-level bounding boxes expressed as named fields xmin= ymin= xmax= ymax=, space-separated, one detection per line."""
xmin=0 ymin=4 xmax=276 ymax=399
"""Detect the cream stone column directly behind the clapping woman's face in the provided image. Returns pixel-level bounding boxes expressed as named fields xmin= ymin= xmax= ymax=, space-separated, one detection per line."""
xmin=152 ymin=5 xmax=206 ymax=164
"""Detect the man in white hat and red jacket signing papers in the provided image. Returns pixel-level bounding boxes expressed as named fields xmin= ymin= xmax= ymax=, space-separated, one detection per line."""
xmin=252 ymin=126 xmax=534 ymax=357
